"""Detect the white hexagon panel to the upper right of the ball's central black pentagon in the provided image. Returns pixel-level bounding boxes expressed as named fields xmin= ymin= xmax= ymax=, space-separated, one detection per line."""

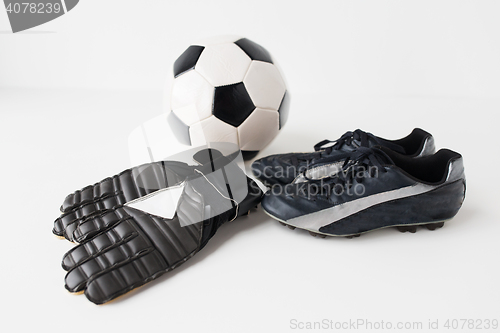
xmin=243 ymin=61 xmax=286 ymax=110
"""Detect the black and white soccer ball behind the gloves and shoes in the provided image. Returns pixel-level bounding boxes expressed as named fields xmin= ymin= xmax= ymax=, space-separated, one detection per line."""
xmin=168 ymin=37 xmax=290 ymax=159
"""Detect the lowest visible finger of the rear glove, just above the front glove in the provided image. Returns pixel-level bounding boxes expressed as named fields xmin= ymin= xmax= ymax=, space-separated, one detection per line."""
xmin=73 ymin=207 xmax=130 ymax=243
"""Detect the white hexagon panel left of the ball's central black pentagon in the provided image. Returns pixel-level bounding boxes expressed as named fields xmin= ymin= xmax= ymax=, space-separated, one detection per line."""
xmin=170 ymin=70 xmax=214 ymax=126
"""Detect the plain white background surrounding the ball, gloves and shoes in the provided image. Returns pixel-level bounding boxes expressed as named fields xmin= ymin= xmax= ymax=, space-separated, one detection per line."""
xmin=0 ymin=0 xmax=500 ymax=332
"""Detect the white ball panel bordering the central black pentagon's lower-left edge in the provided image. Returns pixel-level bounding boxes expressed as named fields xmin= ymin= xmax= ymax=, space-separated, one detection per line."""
xmin=189 ymin=116 xmax=238 ymax=146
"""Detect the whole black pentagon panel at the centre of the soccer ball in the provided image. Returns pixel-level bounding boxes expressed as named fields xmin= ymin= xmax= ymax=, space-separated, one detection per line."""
xmin=212 ymin=82 xmax=255 ymax=127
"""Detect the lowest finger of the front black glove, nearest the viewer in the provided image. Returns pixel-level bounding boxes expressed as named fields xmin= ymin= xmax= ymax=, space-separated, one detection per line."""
xmin=85 ymin=250 xmax=167 ymax=304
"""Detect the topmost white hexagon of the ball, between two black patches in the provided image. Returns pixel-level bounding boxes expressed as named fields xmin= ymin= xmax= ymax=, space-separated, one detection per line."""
xmin=195 ymin=43 xmax=251 ymax=87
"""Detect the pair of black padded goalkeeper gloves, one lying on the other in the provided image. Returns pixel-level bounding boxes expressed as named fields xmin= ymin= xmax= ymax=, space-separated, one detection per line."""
xmin=54 ymin=149 xmax=263 ymax=304
